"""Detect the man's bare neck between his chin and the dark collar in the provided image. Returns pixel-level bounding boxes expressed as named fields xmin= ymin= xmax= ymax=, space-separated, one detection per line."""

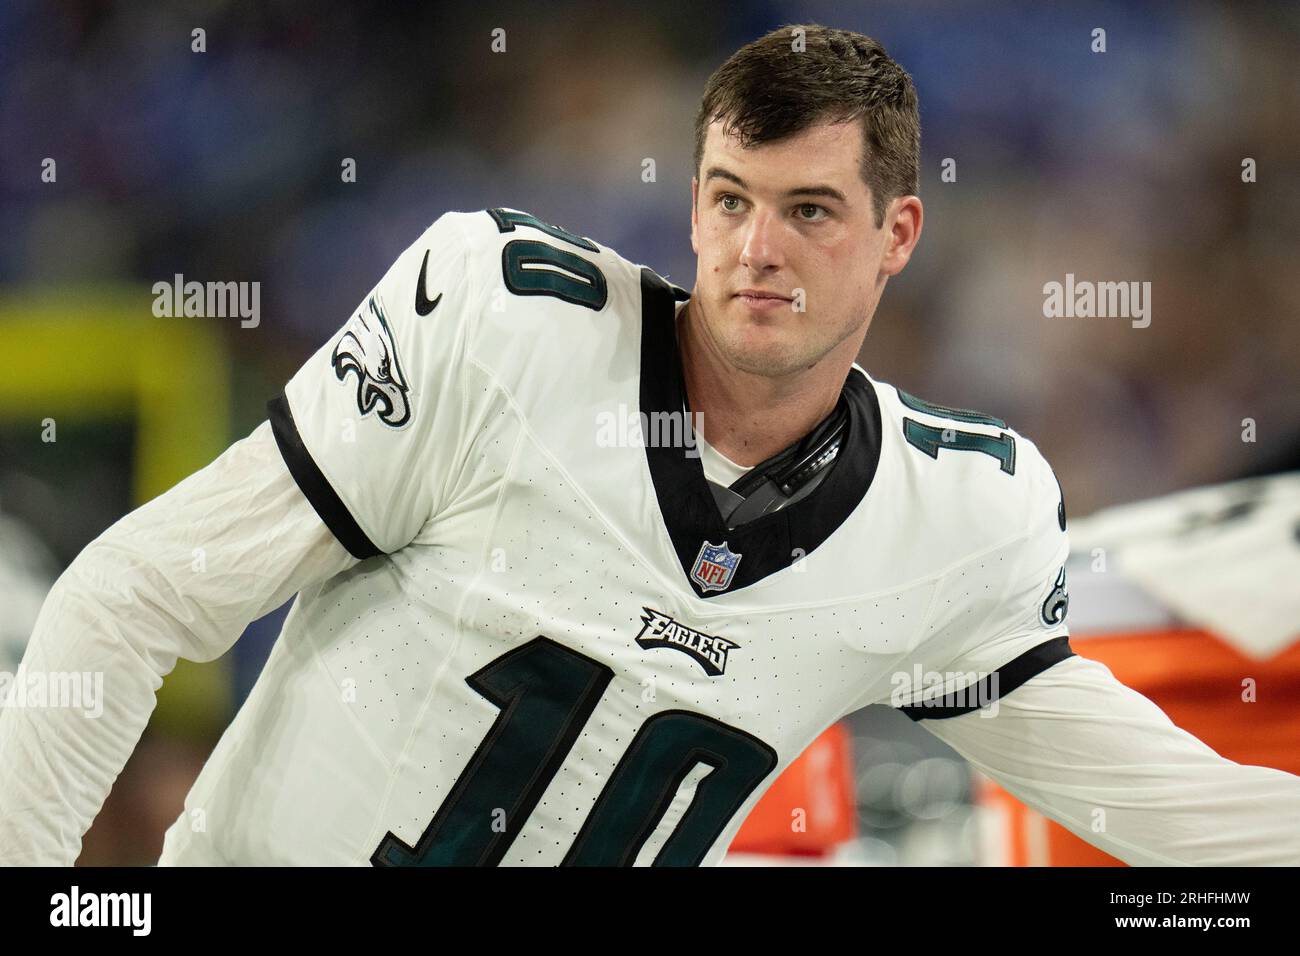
xmin=677 ymin=299 xmax=861 ymax=466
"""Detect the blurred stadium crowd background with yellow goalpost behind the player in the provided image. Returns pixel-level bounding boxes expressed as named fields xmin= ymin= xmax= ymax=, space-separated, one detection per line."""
xmin=0 ymin=0 xmax=1300 ymax=865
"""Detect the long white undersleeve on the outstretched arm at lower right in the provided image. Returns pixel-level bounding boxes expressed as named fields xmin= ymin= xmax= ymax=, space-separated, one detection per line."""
xmin=920 ymin=657 xmax=1300 ymax=866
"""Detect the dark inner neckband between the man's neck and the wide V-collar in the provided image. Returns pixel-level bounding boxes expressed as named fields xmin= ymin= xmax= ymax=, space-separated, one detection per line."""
xmin=709 ymin=395 xmax=849 ymax=529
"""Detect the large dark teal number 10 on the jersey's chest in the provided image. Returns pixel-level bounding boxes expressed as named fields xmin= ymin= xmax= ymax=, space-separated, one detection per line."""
xmin=371 ymin=637 xmax=777 ymax=866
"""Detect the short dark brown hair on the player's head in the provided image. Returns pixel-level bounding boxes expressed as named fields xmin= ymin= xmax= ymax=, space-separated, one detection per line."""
xmin=696 ymin=23 xmax=920 ymax=229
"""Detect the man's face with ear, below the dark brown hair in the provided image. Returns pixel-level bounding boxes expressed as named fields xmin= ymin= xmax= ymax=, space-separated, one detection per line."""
xmin=690 ymin=120 xmax=920 ymax=377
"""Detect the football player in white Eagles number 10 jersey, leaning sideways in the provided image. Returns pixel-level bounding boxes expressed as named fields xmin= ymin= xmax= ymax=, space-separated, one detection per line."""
xmin=0 ymin=26 xmax=1300 ymax=866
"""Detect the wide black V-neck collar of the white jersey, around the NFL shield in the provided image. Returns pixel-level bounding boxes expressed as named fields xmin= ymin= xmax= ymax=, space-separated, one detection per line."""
xmin=641 ymin=268 xmax=880 ymax=598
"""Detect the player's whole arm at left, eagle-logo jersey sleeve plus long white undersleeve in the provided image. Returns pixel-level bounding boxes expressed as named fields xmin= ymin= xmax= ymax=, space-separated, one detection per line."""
xmin=0 ymin=213 xmax=473 ymax=865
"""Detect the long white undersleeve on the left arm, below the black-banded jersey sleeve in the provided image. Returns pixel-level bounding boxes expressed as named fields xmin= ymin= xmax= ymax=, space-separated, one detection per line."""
xmin=0 ymin=421 xmax=356 ymax=866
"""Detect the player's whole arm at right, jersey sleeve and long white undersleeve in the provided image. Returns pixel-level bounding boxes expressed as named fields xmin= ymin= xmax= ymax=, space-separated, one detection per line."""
xmin=904 ymin=444 xmax=1300 ymax=865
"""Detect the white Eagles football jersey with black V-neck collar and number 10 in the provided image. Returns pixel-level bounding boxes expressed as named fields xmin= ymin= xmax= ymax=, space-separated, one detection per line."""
xmin=160 ymin=209 xmax=1071 ymax=866
